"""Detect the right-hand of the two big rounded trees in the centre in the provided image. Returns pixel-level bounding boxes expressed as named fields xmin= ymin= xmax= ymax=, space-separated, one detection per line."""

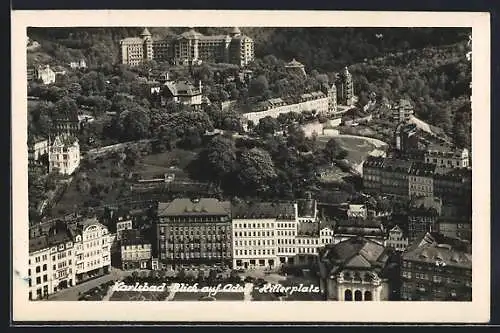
xmin=238 ymin=148 xmax=277 ymax=193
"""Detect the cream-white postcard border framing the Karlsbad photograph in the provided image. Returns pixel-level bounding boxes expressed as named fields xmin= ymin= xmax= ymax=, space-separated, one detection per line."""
xmin=11 ymin=10 xmax=491 ymax=323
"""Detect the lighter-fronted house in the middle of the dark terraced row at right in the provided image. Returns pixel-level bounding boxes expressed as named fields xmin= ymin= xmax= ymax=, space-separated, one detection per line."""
xmin=408 ymin=162 xmax=436 ymax=198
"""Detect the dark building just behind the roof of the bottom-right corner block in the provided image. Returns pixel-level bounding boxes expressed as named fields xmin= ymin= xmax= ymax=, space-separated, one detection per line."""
xmin=408 ymin=197 xmax=443 ymax=243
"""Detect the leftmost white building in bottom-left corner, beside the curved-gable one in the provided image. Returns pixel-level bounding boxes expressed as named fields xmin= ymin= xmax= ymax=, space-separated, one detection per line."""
xmin=28 ymin=225 xmax=77 ymax=300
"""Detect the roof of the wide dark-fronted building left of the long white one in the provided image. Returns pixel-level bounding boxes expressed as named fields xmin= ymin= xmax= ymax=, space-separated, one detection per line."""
xmin=158 ymin=198 xmax=231 ymax=216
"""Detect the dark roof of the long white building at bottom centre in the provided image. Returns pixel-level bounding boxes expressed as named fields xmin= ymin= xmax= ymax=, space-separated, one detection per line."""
xmin=231 ymin=202 xmax=295 ymax=220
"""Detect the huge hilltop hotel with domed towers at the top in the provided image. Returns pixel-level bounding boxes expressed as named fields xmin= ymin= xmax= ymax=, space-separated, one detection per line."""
xmin=120 ymin=28 xmax=254 ymax=67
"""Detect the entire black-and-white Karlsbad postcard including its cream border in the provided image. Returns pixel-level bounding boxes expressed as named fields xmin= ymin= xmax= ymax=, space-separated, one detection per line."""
xmin=13 ymin=11 xmax=490 ymax=321
